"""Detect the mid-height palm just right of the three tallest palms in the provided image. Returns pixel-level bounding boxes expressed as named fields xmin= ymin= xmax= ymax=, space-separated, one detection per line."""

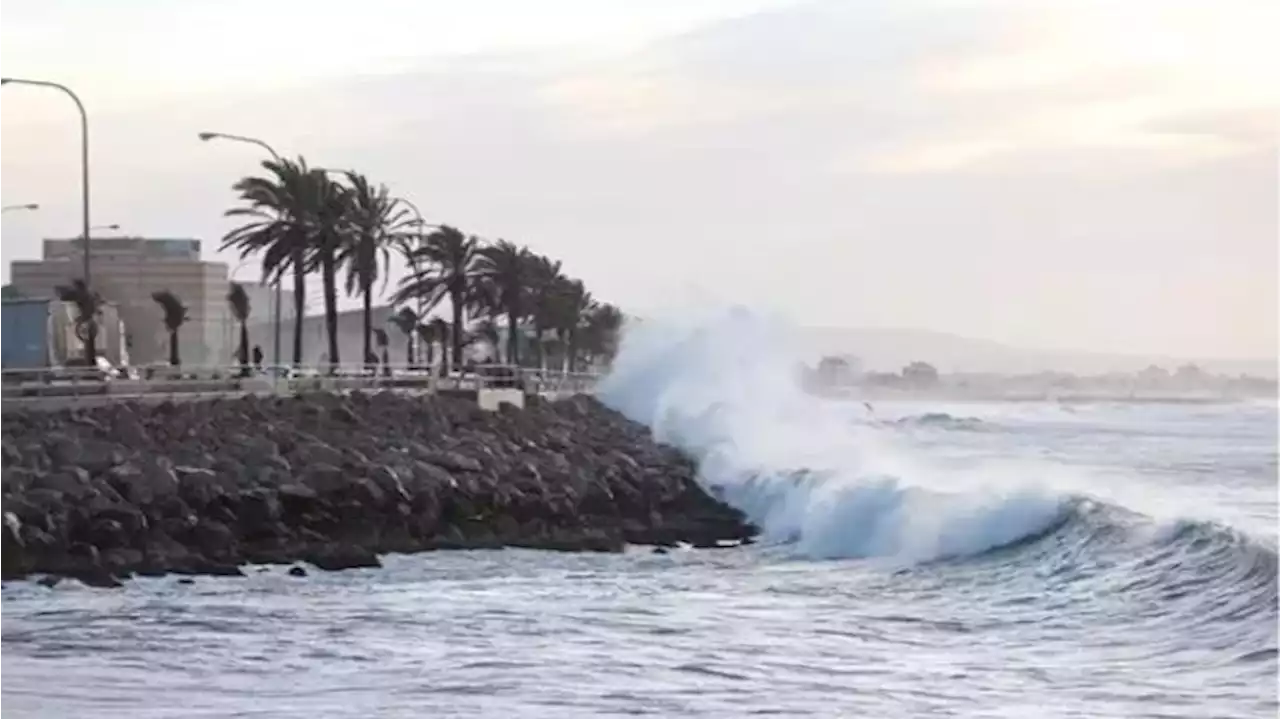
xmin=393 ymin=225 xmax=480 ymax=366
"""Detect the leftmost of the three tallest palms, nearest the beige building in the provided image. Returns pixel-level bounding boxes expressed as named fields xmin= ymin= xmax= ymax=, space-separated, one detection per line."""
xmin=221 ymin=157 xmax=315 ymax=366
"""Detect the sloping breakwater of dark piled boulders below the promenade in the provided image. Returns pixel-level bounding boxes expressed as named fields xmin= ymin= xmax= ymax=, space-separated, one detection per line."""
xmin=0 ymin=394 xmax=754 ymax=586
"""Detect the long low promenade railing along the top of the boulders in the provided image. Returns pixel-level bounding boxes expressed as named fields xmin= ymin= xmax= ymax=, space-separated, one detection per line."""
xmin=0 ymin=365 xmax=598 ymax=409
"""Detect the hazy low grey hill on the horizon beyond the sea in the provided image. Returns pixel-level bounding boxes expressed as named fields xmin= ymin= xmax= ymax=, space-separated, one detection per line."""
xmin=799 ymin=328 xmax=1276 ymax=379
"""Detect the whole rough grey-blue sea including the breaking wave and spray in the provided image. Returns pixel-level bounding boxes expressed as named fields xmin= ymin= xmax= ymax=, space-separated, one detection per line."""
xmin=0 ymin=312 xmax=1280 ymax=719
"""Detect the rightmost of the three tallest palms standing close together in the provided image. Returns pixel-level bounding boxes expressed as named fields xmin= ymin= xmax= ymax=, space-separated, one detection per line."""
xmin=338 ymin=173 xmax=411 ymax=371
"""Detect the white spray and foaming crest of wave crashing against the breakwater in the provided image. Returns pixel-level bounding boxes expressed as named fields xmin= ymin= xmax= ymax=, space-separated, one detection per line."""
xmin=599 ymin=308 xmax=1069 ymax=562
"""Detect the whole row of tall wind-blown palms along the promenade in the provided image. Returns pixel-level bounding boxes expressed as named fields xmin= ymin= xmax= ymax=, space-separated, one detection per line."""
xmin=223 ymin=157 xmax=623 ymax=371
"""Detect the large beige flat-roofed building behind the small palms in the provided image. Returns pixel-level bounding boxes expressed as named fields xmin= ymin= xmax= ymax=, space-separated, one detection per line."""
xmin=10 ymin=237 xmax=234 ymax=366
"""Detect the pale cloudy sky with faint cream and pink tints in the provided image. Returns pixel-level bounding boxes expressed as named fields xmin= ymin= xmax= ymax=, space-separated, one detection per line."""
xmin=0 ymin=0 xmax=1280 ymax=357
